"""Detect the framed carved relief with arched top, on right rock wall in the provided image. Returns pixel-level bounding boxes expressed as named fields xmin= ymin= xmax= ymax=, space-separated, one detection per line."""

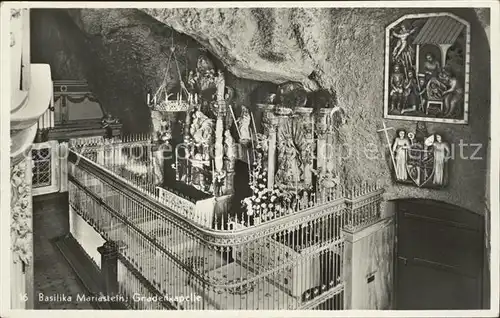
xmin=384 ymin=13 xmax=470 ymax=124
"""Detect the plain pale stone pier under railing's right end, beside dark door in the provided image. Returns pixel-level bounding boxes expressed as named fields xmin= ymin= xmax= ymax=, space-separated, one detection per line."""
xmin=342 ymin=217 xmax=394 ymax=310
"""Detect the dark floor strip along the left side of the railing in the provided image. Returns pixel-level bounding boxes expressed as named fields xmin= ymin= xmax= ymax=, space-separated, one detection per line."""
xmin=33 ymin=193 xmax=93 ymax=309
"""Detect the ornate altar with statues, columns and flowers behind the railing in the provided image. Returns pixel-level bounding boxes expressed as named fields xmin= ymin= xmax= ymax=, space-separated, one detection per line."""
xmin=147 ymin=50 xmax=344 ymax=228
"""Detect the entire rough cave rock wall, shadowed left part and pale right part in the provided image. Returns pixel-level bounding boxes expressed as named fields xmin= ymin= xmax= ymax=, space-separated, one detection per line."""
xmin=32 ymin=8 xmax=491 ymax=213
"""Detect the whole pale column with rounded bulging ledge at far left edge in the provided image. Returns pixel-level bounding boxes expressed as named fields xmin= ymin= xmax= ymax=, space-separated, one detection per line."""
xmin=10 ymin=9 xmax=52 ymax=309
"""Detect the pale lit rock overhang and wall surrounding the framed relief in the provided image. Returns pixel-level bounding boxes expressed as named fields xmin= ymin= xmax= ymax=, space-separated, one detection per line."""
xmin=144 ymin=8 xmax=490 ymax=213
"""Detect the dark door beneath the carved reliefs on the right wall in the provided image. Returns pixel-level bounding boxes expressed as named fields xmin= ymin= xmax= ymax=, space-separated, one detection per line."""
xmin=395 ymin=200 xmax=484 ymax=310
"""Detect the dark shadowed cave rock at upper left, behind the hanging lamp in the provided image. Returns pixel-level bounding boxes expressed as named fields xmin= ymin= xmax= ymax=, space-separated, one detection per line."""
xmin=31 ymin=9 xmax=266 ymax=133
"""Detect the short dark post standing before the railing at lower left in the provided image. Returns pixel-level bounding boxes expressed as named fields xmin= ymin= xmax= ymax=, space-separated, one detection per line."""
xmin=97 ymin=241 xmax=118 ymax=296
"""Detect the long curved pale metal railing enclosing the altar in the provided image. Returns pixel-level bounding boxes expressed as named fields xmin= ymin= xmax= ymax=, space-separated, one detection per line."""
xmin=68 ymin=135 xmax=381 ymax=310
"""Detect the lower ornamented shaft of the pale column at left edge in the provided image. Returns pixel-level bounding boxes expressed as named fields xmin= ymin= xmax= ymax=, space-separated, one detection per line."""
xmin=10 ymin=157 xmax=35 ymax=309
